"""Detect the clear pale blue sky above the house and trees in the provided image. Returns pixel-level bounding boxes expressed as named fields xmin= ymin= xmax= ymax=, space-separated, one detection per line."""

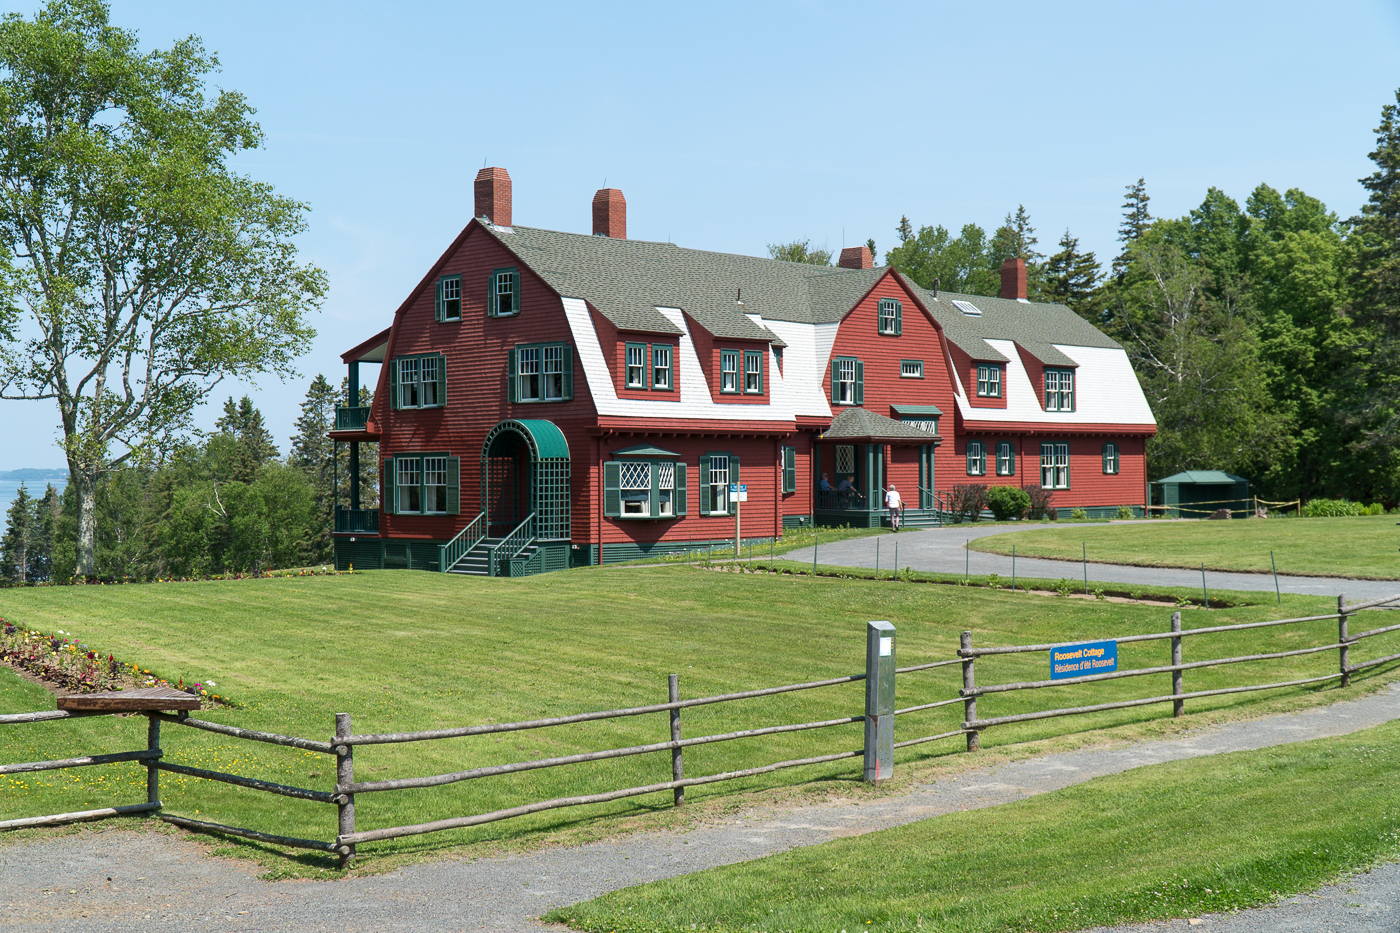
xmin=0 ymin=0 xmax=1400 ymax=469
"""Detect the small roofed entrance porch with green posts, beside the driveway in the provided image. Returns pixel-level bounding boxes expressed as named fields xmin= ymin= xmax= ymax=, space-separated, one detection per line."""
xmin=812 ymin=408 xmax=942 ymax=528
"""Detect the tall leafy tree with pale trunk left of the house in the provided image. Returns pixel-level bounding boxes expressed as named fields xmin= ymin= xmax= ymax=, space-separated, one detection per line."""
xmin=0 ymin=0 xmax=326 ymax=576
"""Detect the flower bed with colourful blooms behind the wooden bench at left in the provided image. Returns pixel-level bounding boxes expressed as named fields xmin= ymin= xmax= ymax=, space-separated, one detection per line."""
xmin=0 ymin=619 xmax=234 ymax=706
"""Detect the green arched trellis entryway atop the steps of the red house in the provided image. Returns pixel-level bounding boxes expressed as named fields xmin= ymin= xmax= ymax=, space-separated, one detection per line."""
xmin=482 ymin=420 xmax=573 ymax=541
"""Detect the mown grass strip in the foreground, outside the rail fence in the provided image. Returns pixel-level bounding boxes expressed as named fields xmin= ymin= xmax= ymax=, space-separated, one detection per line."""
xmin=545 ymin=714 xmax=1400 ymax=933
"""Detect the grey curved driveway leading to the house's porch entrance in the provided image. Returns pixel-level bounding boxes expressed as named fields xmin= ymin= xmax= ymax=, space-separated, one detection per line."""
xmin=785 ymin=523 xmax=1400 ymax=602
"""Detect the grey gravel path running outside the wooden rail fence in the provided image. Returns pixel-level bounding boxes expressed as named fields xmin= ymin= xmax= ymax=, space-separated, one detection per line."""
xmin=0 ymin=684 xmax=1400 ymax=933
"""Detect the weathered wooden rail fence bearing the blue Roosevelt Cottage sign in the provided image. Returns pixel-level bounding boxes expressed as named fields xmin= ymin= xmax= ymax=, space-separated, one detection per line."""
xmin=0 ymin=595 xmax=1400 ymax=866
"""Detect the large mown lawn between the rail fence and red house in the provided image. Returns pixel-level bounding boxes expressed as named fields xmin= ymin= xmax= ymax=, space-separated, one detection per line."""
xmin=0 ymin=566 xmax=1400 ymax=873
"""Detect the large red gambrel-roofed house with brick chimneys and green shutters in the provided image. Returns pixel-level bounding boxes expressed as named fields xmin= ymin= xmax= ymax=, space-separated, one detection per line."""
xmin=332 ymin=168 xmax=1156 ymax=574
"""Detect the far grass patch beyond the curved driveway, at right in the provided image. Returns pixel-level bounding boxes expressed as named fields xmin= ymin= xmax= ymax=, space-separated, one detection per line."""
xmin=973 ymin=516 xmax=1400 ymax=580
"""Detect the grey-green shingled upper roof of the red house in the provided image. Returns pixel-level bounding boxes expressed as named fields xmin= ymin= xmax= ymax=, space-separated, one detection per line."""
xmin=483 ymin=224 xmax=1119 ymax=366
